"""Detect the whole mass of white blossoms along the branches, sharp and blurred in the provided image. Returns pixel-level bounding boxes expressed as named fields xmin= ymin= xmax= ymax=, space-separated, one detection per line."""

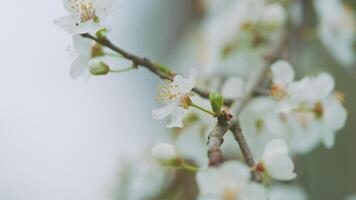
xmin=54 ymin=0 xmax=355 ymax=200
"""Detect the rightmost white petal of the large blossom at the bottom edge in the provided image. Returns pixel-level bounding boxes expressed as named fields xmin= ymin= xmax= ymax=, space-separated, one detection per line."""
xmin=238 ymin=183 xmax=267 ymax=200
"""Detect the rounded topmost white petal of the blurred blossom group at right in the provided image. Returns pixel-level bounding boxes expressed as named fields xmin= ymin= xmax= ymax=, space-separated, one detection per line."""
xmin=271 ymin=60 xmax=294 ymax=85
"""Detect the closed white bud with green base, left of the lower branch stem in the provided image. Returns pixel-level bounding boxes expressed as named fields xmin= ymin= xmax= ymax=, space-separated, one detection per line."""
xmin=151 ymin=143 xmax=179 ymax=166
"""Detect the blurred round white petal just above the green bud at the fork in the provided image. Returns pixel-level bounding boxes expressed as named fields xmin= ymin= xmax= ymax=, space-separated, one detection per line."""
xmin=221 ymin=77 xmax=245 ymax=98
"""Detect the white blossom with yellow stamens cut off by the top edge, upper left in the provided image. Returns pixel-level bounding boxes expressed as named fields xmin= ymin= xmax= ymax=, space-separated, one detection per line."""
xmin=54 ymin=0 xmax=113 ymax=34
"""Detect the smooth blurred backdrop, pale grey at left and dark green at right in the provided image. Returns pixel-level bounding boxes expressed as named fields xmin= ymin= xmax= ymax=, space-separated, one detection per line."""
xmin=0 ymin=0 xmax=356 ymax=200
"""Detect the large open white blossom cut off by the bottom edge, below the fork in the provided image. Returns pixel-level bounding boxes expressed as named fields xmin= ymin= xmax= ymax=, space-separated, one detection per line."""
xmin=196 ymin=161 xmax=266 ymax=200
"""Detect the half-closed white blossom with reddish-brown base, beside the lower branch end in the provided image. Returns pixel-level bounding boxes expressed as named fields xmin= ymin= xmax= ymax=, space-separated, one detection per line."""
xmin=256 ymin=139 xmax=297 ymax=181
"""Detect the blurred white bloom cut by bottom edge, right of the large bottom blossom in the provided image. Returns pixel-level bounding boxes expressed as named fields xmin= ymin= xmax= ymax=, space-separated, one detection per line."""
xmin=268 ymin=184 xmax=307 ymax=200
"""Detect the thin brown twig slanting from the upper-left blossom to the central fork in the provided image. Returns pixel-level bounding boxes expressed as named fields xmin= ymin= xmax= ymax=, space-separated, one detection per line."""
xmin=82 ymin=33 xmax=233 ymax=106
